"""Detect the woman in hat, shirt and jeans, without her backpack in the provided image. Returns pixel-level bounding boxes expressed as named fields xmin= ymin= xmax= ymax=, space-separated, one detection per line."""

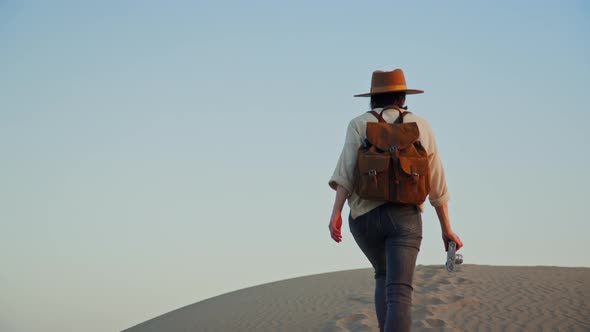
xmin=329 ymin=69 xmax=463 ymax=331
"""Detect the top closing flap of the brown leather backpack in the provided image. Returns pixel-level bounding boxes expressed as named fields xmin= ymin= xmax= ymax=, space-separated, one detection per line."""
xmin=367 ymin=122 xmax=420 ymax=151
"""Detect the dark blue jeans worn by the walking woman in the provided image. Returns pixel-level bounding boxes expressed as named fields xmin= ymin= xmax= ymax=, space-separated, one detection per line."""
xmin=348 ymin=203 xmax=422 ymax=332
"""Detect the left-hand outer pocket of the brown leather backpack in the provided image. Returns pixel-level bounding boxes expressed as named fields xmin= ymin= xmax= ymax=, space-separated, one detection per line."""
xmin=357 ymin=153 xmax=391 ymax=201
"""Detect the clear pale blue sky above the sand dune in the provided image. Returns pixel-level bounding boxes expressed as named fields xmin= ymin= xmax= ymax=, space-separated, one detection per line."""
xmin=0 ymin=1 xmax=590 ymax=332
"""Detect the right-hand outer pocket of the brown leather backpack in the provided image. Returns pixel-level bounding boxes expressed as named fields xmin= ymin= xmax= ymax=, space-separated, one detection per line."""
xmin=396 ymin=157 xmax=430 ymax=204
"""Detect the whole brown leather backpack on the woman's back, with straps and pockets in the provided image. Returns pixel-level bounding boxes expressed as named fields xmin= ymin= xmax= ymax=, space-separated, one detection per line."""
xmin=355 ymin=109 xmax=430 ymax=205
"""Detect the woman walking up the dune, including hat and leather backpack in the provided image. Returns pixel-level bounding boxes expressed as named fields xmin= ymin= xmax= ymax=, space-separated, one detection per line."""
xmin=329 ymin=69 xmax=463 ymax=332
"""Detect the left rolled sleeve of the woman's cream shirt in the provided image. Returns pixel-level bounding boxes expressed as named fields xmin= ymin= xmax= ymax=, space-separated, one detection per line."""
xmin=328 ymin=119 xmax=362 ymax=195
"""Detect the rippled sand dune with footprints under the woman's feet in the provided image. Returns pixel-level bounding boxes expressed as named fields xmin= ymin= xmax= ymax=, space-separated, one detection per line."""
xmin=125 ymin=265 xmax=590 ymax=332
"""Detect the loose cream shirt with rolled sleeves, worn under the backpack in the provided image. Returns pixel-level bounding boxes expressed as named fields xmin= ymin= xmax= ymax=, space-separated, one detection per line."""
xmin=328 ymin=108 xmax=450 ymax=218
